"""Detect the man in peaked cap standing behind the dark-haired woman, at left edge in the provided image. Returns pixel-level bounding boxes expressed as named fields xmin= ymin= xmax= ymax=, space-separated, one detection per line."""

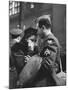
xmin=9 ymin=28 xmax=23 ymax=88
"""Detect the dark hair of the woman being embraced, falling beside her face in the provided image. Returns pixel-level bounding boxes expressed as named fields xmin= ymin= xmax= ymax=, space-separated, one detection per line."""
xmin=20 ymin=27 xmax=37 ymax=55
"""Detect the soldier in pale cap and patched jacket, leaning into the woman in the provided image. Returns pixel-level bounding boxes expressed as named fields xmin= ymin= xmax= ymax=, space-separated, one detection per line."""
xmin=37 ymin=15 xmax=65 ymax=85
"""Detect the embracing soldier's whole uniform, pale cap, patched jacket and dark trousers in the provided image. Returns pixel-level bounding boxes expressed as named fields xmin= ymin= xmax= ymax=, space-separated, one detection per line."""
xmin=31 ymin=15 xmax=60 ymax=86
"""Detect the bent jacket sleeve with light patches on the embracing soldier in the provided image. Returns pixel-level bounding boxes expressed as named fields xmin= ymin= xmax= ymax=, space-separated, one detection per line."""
xmin=40 ymin=39 xmax=58 ymax=71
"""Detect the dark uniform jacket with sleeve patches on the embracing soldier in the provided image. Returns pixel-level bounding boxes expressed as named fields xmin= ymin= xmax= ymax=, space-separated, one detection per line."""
xmin=39 ymin=33 xmax=60 ymax=73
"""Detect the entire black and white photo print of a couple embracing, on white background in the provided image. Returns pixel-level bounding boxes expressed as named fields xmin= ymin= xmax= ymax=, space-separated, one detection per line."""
xmin=8 ymin=0 xmax=67 ymax=89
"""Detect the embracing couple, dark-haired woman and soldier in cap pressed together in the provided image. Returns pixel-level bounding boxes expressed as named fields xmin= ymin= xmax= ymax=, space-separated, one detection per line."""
xmin=12 ymin=15 xmax=65 ymax=88
